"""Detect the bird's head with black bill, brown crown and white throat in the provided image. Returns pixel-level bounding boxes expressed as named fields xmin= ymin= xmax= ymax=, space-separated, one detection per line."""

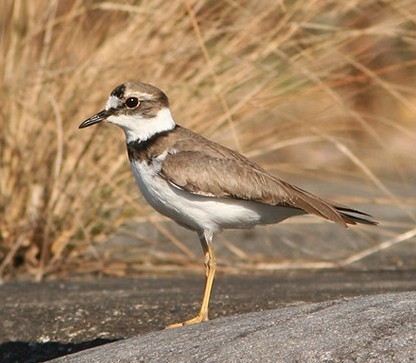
xmin=79 ymin=82 xmax=175 ymax=143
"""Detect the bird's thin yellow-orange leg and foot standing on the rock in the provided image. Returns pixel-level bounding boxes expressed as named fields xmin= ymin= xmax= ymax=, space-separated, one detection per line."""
xmin=166 ymin=233 xmax=217 ymax=328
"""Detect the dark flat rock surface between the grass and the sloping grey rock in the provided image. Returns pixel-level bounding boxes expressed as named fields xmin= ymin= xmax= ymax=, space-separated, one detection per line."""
xmin=0 ymin=270 xmax=416 ymax=363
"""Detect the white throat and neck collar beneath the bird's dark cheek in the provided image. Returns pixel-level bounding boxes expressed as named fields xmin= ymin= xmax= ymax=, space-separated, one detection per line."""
xmin=107 ymin=108 xmax=175 ymax=143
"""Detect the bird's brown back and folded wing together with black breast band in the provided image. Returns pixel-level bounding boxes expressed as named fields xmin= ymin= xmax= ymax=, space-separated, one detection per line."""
xmin=128 ymin=126 xmax=371 ymax=226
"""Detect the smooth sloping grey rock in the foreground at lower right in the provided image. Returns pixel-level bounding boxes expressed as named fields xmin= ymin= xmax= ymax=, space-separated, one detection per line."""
xmin=53 ymin=292 xmax=416 ymax=363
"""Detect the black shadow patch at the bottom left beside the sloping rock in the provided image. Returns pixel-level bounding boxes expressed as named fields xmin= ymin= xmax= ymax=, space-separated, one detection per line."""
xmin=0 ymin=338 xmax=119 ymax=363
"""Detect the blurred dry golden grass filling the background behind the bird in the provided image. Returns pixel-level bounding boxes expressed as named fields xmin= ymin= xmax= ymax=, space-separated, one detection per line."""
xmin=0 ymin=0 xmax=416 ymax=279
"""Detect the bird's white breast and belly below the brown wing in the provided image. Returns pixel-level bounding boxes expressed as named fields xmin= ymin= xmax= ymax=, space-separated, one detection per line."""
xmin=131 ymin=161 xmax=304 ymax=232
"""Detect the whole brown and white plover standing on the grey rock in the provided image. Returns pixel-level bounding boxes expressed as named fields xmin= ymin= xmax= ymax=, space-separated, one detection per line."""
xmin=79 ymin=81 xmax=377 ymax=328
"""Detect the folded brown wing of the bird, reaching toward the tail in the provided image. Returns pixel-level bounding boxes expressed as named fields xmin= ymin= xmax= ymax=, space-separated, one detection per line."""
xmin=160 ymin=150 xmax=372 ymax=226
